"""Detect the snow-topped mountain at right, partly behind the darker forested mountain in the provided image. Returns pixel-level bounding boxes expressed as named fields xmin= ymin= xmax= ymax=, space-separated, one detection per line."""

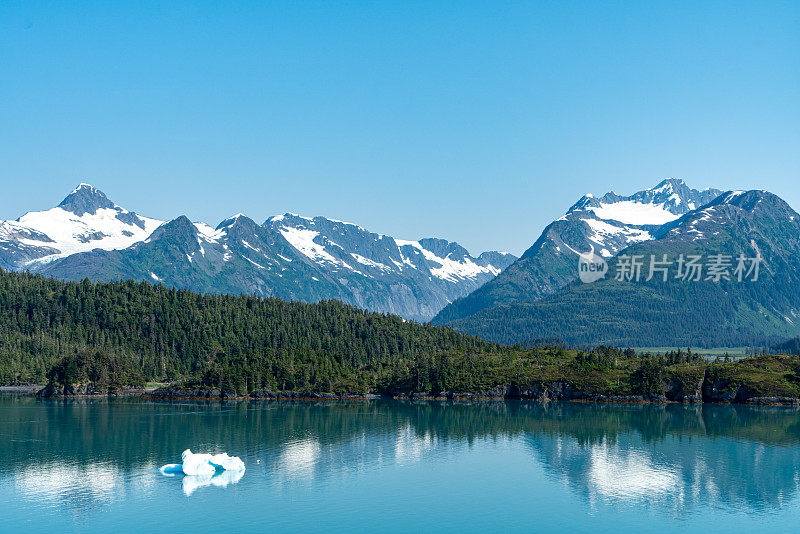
xmin=434 ymin=179 xmax=721 ymax=324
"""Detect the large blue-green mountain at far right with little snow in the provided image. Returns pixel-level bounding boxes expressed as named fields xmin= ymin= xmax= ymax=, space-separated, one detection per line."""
xmin=444 ymin=191 xmax=800 ymax=347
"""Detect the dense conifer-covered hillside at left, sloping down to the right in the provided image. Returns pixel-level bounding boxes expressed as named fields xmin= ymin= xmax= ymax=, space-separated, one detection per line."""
xmin=0 ymin=271 xmax=498 ymax=388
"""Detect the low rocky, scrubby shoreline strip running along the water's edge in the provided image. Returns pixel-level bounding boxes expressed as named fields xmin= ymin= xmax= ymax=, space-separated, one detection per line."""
xmin=15 ymin=356 xmax=800 ymax=406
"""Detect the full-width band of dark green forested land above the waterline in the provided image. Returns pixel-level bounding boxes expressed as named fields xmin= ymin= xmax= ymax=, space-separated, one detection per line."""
xmin=0 ymin=272 xmax=800 ymax=400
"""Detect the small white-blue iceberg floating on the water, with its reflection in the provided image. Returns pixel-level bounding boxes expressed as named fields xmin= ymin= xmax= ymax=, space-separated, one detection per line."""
xmin=159 ymin=449 xmax=244 ymax=495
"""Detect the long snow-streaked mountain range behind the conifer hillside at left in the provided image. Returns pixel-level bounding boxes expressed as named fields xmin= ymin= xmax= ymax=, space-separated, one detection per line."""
xmin=0 ymin=184 xmax=516 ymax=320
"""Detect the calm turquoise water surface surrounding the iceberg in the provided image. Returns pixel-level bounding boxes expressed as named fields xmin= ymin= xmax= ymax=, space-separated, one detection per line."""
xmin=0 ymin=396 xmax=800 ymax=534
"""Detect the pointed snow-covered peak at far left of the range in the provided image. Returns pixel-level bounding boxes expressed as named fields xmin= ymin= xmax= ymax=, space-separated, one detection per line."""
xmin=0 ymin=184 xmax=162 ymax=268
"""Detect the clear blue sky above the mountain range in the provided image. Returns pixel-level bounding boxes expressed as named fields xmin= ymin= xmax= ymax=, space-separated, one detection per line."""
xmin=0 ymin=0 xmax=800 ymax=253
